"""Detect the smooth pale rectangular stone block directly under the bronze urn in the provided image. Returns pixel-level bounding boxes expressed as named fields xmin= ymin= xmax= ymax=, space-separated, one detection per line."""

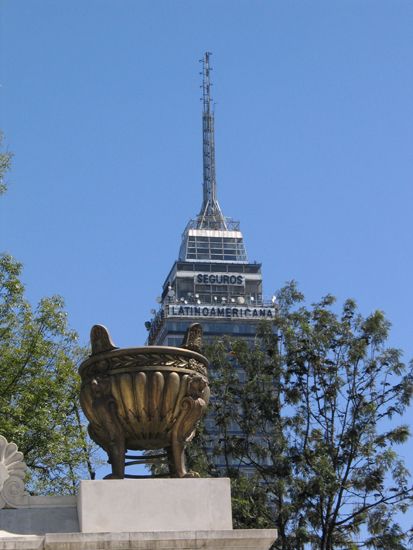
xmin=78 ymin=478 xmax=232 ymax=533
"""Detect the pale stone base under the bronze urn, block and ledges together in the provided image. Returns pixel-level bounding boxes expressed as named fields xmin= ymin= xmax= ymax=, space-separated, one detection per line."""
xmin=0 ymin=478 xmax=277 ymax=550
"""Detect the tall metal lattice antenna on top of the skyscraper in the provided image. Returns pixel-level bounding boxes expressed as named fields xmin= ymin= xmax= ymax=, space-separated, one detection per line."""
xmin=198 ymin=52 xmax=227 ymax=229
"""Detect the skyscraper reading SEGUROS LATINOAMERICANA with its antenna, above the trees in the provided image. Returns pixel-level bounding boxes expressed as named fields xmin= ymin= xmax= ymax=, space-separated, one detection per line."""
xmin=147 ymin=52 xmax=274 ymax=346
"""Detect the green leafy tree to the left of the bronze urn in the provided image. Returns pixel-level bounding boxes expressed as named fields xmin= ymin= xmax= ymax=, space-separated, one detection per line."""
xmin=0 ymin=255 xmax=93 ymax=494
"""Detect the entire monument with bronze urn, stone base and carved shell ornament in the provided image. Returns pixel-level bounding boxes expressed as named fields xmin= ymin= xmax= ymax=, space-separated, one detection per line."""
xmin=0 ymin=325 xmax=277 ymax=550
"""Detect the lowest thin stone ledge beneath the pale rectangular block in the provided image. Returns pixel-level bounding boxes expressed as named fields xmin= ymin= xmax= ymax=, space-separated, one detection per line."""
xmin=0 ymin=529 xmax=277 ymax=550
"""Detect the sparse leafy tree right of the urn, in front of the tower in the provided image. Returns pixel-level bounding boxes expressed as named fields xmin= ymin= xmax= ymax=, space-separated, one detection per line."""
xmin=192 ymin=283 xmax=413 ymax=550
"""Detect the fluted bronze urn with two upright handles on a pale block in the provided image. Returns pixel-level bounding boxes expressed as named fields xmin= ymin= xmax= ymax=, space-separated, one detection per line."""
xmin=79 ymin=324 xmax=210 ymax=479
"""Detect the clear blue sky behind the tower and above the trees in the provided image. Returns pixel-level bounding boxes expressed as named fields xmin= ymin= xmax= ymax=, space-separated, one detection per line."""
xmin=0 ymin=0 xmax=413 ymax=508
